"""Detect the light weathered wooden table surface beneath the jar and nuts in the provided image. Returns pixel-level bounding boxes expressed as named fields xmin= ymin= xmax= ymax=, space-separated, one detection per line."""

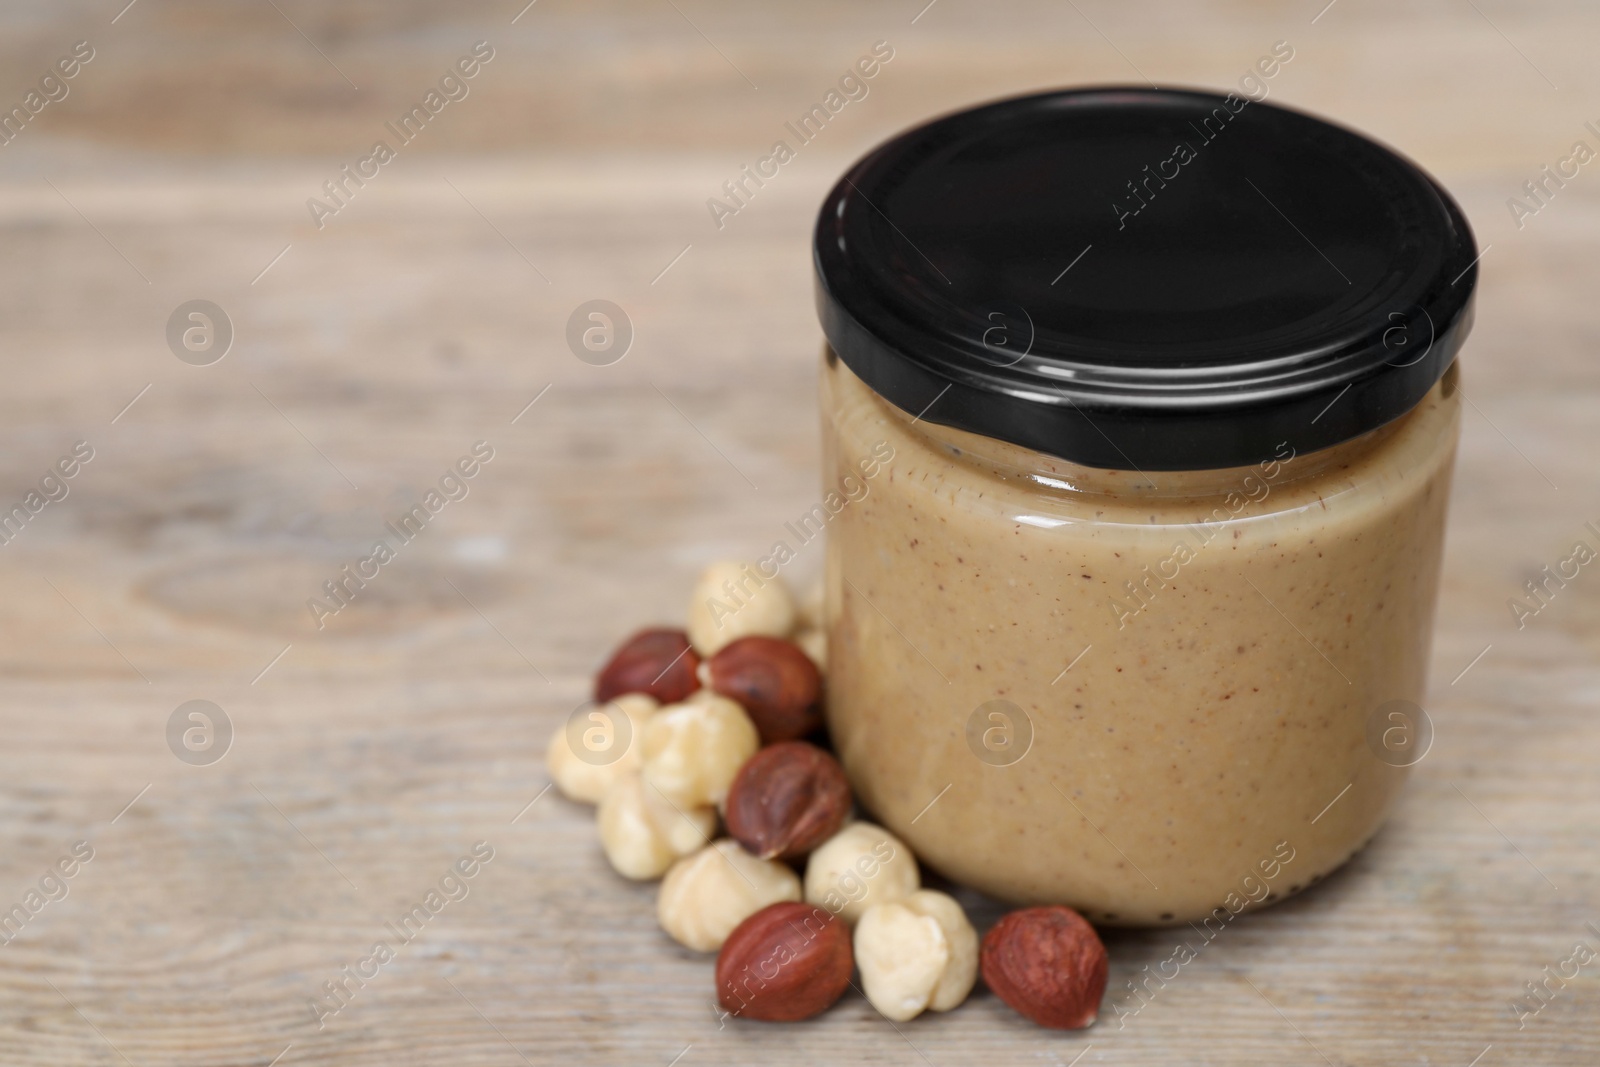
xmin=0 ymin=0 xmax=1600 ymax=1067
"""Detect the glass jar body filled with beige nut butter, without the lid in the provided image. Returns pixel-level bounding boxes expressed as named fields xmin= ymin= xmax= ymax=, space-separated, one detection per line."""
xmin=821 ymin=352 xmax=1459 ymax=925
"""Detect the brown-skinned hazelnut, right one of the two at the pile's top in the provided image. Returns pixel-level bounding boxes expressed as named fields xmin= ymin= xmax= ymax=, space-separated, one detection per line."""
xmin=699 ymin=637 xmax=822 ymax=744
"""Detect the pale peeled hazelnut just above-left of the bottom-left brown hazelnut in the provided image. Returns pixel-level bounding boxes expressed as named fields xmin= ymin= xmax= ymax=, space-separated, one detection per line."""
xmin=656 ymin=838 xmax=800 ymax=952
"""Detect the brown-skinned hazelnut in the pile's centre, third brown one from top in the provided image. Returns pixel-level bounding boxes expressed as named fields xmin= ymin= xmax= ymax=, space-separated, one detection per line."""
xmin=723 ymin=741 xmax=850 ymax=859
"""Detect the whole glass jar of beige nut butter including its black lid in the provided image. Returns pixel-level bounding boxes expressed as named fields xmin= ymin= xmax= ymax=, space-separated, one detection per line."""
xmin=814 ymin=88 xmax=1477 ymax=925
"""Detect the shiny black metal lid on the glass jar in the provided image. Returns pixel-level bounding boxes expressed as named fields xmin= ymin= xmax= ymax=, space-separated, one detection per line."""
xmin=814 ymin=88 xmax=1478 ymax=470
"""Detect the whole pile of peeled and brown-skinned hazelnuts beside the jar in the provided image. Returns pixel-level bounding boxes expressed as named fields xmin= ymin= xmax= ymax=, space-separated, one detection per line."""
xmin=547 ymin=561 xmax=1107 ymax=1030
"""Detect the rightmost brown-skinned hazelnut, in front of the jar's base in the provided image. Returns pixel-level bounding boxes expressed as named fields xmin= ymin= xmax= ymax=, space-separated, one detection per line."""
xmin=979 ymin=905 xmax=1107 ymax=1030
